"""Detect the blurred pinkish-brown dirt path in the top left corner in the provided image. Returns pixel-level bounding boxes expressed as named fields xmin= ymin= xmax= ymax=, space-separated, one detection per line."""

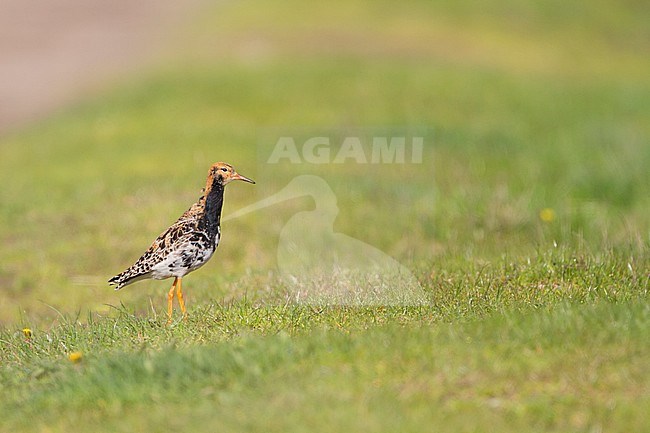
xmin=0 ymin=0 xmax=201 ymax=135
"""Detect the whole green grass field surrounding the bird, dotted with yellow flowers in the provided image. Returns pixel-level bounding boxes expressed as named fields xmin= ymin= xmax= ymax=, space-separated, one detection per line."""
xmin=0 ymin=0 xmax=650 ymax=432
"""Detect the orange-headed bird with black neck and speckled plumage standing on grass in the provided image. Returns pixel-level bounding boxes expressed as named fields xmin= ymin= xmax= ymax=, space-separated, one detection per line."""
xmin=108 ymin=162 xmax=255 ymax=314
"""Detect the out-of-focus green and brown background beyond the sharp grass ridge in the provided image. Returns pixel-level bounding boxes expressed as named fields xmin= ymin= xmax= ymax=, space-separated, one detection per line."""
xmin=0 ymin=0 xmax=650 ymax=321
